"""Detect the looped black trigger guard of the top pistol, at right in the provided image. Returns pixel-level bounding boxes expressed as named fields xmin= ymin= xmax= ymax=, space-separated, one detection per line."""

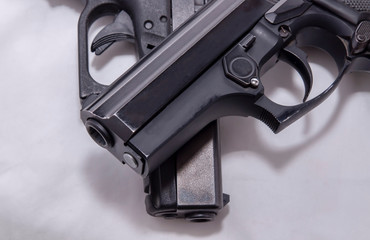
xmin=251 ymin=14 xmax=356 ymax=133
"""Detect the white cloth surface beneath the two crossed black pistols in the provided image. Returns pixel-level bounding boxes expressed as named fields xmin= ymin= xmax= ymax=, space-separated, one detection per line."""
xmin=0 ymin=0 xmax=370 ymax=240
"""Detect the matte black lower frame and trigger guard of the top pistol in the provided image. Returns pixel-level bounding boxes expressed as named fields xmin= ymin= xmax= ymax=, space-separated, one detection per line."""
xmin=130 ymin=2 xmax=366 ymax=174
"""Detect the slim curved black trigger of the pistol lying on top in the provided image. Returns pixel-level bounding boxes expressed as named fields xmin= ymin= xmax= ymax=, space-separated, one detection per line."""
xmin=279 ymin=44 xmax=313 ymax=102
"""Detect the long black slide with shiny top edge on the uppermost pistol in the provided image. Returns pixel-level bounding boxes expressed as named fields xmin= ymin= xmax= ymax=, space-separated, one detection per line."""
xmin=83 ymin=0 xmax=253 ymax=141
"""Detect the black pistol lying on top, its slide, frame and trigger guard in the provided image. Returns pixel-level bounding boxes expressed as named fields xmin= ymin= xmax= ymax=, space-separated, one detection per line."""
xmin=81 ymin=0 xmax=368 ymax=176
